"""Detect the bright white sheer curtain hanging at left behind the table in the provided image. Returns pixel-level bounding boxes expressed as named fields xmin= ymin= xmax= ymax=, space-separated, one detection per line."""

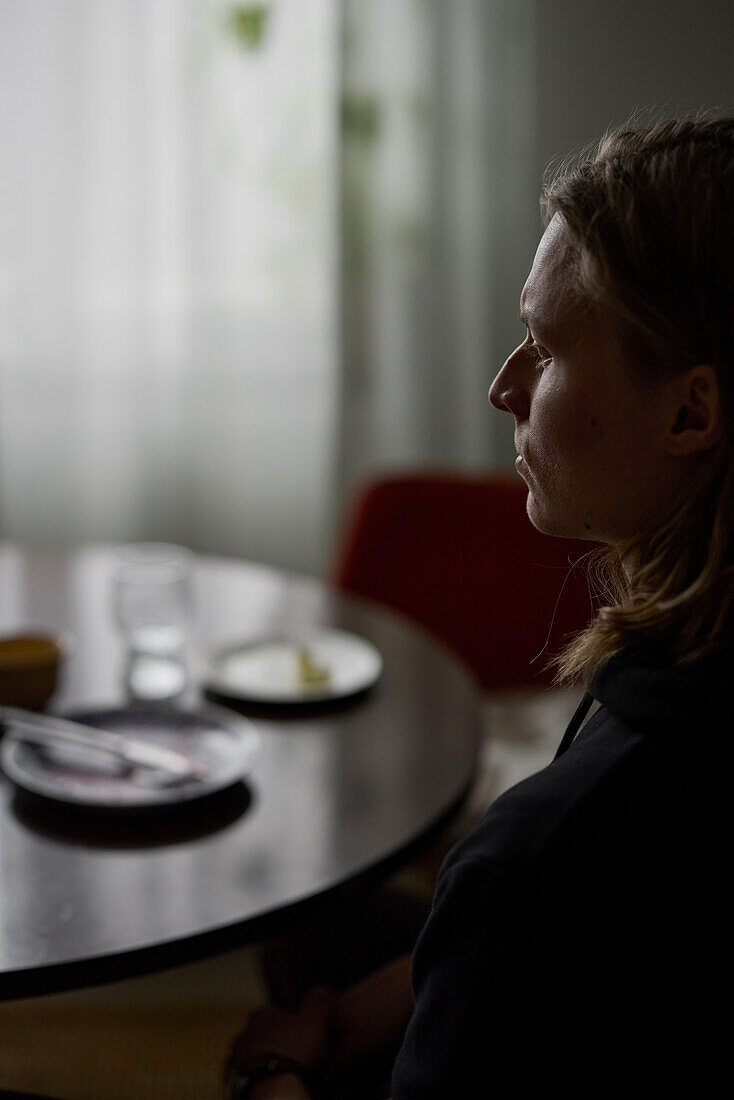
xmin=0 ymin=0 xmax=338 ymax=569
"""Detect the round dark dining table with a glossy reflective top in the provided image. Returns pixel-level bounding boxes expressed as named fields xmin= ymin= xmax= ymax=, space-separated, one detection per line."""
xmin=0 ymin=543 xmax=482 ymax=999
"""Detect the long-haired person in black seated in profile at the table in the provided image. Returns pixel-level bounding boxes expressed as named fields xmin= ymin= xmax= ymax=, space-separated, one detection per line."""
xmin=225 ymin=119 xmax=734 ymax=1100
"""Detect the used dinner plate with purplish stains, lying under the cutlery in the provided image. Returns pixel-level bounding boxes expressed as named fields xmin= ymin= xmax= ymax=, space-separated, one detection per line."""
xmin=0 ymin=706 xmax=260 ymax=810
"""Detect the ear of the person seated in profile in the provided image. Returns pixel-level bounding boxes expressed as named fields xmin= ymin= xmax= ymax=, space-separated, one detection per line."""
xmin=667 ymin=363 xmax=722 ymax=457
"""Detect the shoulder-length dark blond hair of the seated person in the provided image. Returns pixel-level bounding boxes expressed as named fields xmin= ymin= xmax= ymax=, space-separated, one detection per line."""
xmin=541 ymin=109 xmax=734 ymax=683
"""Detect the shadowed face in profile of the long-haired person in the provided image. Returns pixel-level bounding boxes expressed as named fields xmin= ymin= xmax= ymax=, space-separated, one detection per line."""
xmin=490 ymin=215 xmax=680 ymax=542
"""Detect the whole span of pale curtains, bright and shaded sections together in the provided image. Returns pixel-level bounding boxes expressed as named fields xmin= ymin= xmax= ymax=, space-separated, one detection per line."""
xmin=0 ymin=0 xmax=538 ymax=571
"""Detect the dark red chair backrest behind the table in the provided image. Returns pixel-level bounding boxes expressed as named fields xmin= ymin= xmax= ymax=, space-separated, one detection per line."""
xmin=332 ymin=473 xmax=594 ymax=690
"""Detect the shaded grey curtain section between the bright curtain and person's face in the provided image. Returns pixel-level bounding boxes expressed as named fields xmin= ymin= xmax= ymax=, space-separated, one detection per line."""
xmin=340 ymin=0 xmax=539 ymax=499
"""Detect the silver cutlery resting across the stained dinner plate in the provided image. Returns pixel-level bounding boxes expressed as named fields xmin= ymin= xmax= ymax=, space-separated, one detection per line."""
xmin=0 ymin=706 xmax=208 ymax=783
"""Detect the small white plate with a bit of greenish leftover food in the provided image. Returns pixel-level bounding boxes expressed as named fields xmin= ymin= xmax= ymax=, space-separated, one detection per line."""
xmin=204 ymin=630 xmax=382 ymax=704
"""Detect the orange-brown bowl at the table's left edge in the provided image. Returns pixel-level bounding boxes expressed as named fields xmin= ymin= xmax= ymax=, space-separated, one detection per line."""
xmin=0 ymin=631 xmax=72 ymax=711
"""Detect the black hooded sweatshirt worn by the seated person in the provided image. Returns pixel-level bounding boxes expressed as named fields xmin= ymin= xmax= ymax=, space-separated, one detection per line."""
xmin=393 ymin=651 xmax=734 ymax=1100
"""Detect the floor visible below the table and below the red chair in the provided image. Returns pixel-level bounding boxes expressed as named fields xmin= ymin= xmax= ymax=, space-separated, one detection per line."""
xmin=0 ymin=690 xmax=581 ymax=1100
